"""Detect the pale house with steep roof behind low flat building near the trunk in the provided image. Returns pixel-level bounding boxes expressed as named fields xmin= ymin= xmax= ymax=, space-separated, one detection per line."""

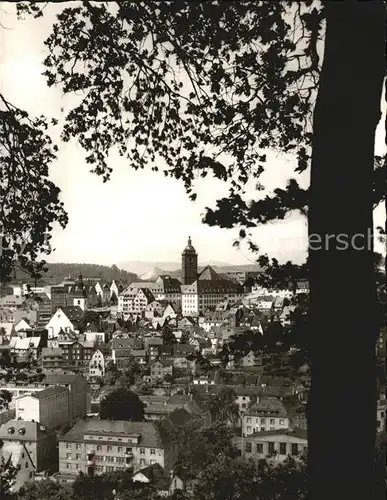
xmin=242 ymin=398 xmax=289 ymax=436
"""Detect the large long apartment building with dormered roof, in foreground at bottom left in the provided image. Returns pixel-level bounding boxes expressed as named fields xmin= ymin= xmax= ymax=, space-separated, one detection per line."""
xmin=59 ymin=419 xmax=176 ymax=479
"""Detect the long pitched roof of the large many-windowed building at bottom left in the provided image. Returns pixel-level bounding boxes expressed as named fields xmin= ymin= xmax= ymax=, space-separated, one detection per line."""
xmin=60 ymin=419 xmax=163 ymax=448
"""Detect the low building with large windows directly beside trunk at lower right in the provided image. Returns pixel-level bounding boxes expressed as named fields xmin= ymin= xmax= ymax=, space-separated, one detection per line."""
xmin=233 ymin=429 xmax=308 ymax=462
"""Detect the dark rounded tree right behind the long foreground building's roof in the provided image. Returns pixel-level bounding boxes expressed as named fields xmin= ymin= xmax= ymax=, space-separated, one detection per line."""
xmin=99 ymin=387 xmax=144 ymax=422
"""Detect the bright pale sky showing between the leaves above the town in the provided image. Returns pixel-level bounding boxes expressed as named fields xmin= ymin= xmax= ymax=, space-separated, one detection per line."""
xmin=0 ymin=3 xmax=385 ymax=265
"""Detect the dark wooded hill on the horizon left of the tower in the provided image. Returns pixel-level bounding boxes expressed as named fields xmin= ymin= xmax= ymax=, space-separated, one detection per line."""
xmin=7 ymin=262 xmax=137 ymax=286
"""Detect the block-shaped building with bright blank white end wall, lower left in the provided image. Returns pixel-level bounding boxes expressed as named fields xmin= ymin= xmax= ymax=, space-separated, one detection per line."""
xmin=15 ymin=385 xmax=69 ymax=429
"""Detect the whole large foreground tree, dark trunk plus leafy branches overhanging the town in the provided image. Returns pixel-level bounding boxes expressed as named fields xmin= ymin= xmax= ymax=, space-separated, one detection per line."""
xmin=21 ymin=0 xmax=385 ymax=499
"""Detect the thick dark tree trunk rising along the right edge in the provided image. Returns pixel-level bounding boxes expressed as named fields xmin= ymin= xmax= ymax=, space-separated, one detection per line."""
xmin=308 ymin=0 xmax=385 ymax=500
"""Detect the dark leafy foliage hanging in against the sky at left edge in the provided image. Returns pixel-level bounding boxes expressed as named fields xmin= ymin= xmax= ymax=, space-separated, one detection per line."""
xmin=0 ymin=94 xmax=67 ymax=285
